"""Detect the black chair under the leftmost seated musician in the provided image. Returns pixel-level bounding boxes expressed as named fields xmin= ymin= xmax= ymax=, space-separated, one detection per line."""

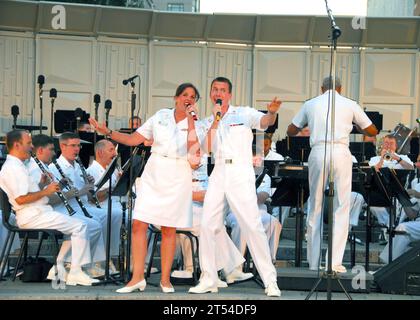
xmin=0 ymin=188 xmax=63 ymax=281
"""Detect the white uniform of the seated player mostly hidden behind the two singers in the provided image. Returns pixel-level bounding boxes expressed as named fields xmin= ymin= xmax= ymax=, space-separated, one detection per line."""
xmin=177 ymin=155 xmax=245 ymax=274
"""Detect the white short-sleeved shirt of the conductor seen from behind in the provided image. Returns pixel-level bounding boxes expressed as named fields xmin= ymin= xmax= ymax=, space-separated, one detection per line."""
xmin=292 ymin=90 xmax=372 ymax=147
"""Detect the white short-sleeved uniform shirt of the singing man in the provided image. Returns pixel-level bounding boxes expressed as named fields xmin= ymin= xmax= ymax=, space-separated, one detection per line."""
xmin=203 ymin=106 xmax=264 ymax=166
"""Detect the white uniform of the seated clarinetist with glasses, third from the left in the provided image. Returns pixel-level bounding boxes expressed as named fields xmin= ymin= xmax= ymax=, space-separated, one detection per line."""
xmin=48 ymin=155 xmax=110 ymax=262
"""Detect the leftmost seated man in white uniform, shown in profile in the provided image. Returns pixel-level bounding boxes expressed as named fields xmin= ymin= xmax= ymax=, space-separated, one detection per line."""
xmin=0 ymin=130 xmax=97 ymax=286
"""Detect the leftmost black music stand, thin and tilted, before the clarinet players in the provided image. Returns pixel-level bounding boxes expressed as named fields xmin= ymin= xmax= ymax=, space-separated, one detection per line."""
xmin=94 ymin=156 xmax=120 ymax=284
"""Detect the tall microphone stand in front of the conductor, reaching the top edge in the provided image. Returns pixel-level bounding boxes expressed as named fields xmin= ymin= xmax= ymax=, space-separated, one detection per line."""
xmin=305 ymin=0 xmax=352 ymax=300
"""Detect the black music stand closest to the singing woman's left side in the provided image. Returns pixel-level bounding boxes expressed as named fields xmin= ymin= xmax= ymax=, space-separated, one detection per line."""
xmin=112 ymin=150 xmax=146 ymax=280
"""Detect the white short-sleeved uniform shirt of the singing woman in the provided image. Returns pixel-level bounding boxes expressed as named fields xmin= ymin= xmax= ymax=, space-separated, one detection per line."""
xmin=136 ymin=109 xmax=204 ymax=159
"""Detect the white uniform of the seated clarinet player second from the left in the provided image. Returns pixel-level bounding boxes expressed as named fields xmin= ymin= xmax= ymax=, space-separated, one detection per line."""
xmin=27 ymin=158 xmax=105 ymax=262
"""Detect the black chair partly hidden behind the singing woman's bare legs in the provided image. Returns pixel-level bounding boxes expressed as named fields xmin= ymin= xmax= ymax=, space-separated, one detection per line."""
xmin=145 ymin=225 xmax=199 ymax=284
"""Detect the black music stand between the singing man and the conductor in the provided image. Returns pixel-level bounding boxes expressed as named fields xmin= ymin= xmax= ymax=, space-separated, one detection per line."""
xmin=271 ymin=163 xmax=309 ymax=267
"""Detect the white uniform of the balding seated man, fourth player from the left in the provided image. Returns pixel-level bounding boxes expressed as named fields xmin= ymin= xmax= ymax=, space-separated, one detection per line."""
xmin=86 ymin=160 xmax=122 ymax=256
